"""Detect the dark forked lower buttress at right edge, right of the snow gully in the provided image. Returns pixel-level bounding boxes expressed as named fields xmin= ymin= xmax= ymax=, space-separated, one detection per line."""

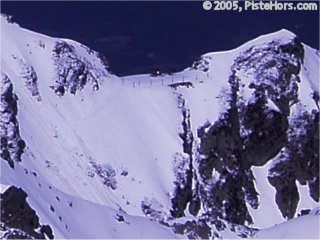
xmin=268 ymin=111 xmax=319 ymax=218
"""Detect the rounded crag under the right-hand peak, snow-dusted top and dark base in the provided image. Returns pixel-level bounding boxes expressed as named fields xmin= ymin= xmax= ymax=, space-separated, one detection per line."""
xmin=233 ymin=39 xmax=304 ymax=169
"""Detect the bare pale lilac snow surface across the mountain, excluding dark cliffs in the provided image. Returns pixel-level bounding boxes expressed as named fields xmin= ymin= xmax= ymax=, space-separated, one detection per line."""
xmin=1 ymin=15 xmax=319 ymax=238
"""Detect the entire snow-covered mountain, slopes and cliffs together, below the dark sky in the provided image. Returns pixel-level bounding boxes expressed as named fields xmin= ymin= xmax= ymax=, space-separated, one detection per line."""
xmin=0 ymin=14 xmax=319 ymax=238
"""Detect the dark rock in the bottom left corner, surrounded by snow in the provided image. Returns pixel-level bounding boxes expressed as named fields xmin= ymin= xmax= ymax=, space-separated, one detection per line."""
xmin=1 ymin=186 xmax=54 ymax=239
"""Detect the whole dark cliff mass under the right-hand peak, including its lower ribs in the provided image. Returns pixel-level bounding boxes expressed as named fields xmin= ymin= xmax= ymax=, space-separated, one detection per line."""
xmin=172 ymin=35 xmax=319 ymax=230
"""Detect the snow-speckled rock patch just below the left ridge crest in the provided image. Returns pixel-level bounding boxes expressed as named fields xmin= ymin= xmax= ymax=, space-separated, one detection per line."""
xmin=52 ymin=41 xmax=107 ymax=96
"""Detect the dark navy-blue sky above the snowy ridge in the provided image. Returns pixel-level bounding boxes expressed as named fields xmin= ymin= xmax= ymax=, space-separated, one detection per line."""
xmin=1 ymin=1 xmax=319 ymax=75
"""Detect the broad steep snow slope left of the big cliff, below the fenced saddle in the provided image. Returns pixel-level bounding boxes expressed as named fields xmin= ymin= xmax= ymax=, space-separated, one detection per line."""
xmin=1 ymin=15 xmax=182 ymax=238
